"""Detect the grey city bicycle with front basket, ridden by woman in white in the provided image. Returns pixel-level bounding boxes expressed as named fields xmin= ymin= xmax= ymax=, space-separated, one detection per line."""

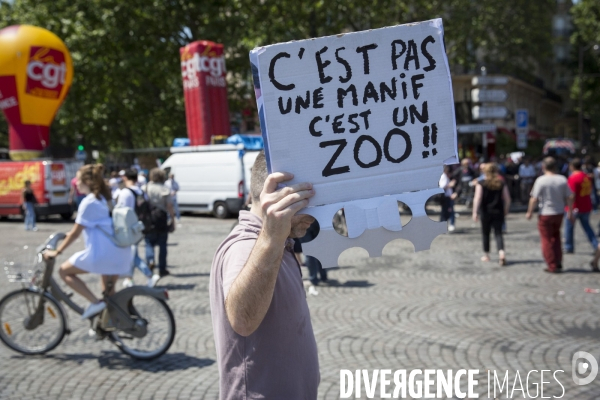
xmin=0 ymin=233 xmax=175 ymax=360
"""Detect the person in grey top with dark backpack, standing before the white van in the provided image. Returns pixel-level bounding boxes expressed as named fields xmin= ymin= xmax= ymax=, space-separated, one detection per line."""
xmin=144 ymin=168 xmax=175 ymax=277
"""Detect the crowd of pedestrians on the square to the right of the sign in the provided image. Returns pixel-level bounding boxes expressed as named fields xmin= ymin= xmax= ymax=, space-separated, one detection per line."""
xmin=439 ymin=155 xmax=600 ymax=273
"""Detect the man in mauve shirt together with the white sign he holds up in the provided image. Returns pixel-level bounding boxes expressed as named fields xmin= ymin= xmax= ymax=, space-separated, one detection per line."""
xmin=210 ymin=19 xmax=458 ymax=400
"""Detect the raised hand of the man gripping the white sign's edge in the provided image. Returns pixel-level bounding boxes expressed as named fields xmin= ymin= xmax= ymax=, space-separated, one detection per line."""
xmin=260 ymin=172 xmax=315 ymax=242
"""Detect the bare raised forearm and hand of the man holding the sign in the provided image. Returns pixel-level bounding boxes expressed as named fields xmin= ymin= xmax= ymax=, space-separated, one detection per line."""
xmin=225 ymin=173 xmax=314 ymax=336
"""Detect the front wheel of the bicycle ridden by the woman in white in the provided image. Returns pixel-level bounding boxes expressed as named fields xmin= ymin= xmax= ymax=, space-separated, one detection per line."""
xmin=0 ymin=289 xmax=66 ymax=354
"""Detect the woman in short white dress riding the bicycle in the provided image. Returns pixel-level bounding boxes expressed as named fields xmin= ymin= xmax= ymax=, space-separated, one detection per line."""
xmin=44 ymin=164 xmax=131 ymax=319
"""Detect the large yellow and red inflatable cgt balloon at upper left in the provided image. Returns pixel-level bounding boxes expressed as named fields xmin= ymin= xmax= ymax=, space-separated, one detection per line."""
xmin=0 ymin=25 xmax=73 ymax=160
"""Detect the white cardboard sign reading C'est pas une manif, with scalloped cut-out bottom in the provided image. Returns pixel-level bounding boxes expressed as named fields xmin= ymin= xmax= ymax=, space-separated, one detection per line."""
xmin=250 ymin=19 xmax=458 ymax=266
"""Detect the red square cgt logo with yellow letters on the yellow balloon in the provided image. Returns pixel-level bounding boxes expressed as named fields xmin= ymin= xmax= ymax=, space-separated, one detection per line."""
xmin=25 ymin=46 xmax=67 ymax=99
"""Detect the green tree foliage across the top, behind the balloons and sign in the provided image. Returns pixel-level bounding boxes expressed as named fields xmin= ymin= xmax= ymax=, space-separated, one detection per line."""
xmin=0 ymin=0 xmax=554 ymax=151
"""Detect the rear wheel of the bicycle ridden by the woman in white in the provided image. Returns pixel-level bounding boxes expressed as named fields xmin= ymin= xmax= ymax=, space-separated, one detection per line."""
xmin=111 ymin=294 xmax=175 ymax=360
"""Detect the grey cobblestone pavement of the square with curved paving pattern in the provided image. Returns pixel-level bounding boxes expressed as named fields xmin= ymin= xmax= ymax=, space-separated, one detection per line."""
xmin=0 ymin=214 xmax=600 ymax=400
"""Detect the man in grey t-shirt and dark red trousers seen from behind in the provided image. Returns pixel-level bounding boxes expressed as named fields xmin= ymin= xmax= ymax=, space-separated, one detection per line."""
xmin=526 ymin=157 xmax=573 ymax=273
